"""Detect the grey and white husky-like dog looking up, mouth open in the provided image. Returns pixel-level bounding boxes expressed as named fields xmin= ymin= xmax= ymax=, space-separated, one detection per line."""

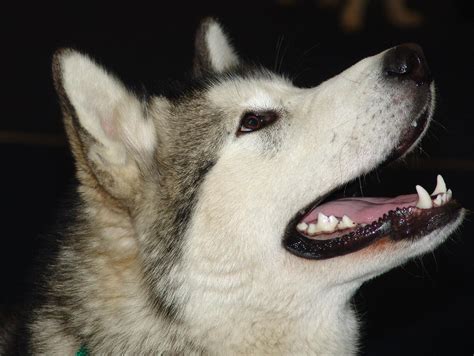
xmin=0 ymin=19 xmax=465 ymax=355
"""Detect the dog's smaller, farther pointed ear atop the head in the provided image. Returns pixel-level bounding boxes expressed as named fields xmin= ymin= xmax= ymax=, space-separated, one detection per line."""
xmin=194 ymin=18 xmax=240 ymax=76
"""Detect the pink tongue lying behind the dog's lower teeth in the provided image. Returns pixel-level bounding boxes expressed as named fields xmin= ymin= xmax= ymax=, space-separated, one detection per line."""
xmin=303 ymin=194 xmax=418 ymax=224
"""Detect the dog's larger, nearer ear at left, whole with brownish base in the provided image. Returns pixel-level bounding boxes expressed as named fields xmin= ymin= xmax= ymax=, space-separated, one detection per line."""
xmin=53 ymin=49 xmax=156 ymax=207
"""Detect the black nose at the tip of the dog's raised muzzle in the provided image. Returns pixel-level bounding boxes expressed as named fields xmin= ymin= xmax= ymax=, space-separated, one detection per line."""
xmin=383 ymin=43 xmax=432 ymax=85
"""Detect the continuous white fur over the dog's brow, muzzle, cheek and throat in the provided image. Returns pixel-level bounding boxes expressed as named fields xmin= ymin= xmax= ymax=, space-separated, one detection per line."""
xmin=172 ymin=48 xmax=454 ymax=355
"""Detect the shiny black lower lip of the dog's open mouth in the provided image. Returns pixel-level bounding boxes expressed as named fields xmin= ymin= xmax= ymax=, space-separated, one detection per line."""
xmin=283 ymin=200 xmax=462 ymax=260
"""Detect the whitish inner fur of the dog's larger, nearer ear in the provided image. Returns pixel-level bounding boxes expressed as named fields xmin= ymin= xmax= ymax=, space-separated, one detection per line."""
xmin=61 ymin=52 xmax=156 ymax=164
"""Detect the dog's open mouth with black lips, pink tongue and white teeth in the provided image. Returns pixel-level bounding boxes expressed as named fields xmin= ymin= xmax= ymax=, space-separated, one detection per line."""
xmin=283 ymin=96 xmax=461 ymax=260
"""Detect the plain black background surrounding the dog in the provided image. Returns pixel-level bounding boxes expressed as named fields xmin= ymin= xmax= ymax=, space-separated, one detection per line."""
xmin=0 ymin=0 xmax=474 ymax=355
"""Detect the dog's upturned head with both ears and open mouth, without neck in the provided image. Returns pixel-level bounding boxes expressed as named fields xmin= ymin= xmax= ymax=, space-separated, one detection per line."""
xmin=54 ymin=20 xmax=463 ymax=354
